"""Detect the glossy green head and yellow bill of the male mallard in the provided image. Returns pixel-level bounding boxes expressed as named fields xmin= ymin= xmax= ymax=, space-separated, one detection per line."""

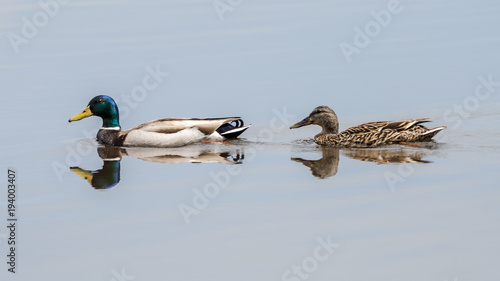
xmin=68 ymin=95 xmax=120 ymax=127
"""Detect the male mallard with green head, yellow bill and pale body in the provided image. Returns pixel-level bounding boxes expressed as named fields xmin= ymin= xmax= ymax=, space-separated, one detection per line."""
xmin=69 ymin=96 xmax=250 ymax=147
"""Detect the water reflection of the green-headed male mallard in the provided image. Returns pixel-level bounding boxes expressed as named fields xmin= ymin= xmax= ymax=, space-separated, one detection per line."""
xmin=70 ymin=146 xmax=245 ymax=189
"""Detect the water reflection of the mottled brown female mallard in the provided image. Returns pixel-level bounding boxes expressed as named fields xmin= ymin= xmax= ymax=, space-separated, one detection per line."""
xmin=291 ymin=146 xmax=432 ymax=179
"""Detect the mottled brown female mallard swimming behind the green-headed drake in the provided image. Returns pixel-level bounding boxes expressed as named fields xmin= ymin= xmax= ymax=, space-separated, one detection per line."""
xmin=290 ymin=106 xmax=446 ymax=147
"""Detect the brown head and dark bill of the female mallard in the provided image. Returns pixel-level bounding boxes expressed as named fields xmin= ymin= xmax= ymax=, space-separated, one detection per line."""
xmin=290 ymin=105 xmax=339 ymax=134
